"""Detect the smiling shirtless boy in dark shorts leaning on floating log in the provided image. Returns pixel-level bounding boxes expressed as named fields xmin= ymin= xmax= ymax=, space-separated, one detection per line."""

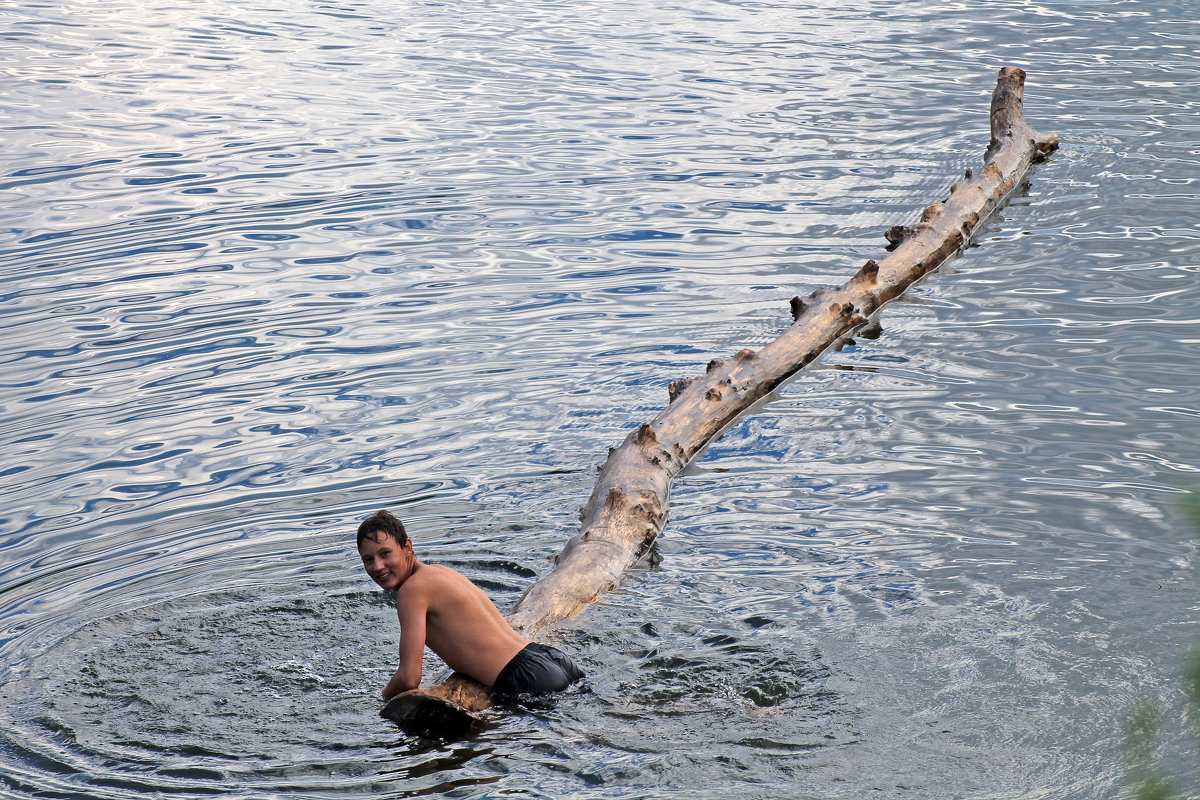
xmin=359 ymin=511 xmax=583 ymax=699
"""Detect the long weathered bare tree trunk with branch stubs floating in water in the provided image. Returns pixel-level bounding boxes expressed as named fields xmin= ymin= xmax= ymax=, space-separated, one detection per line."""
xmin=382 ymin=67 xmax=1058 ymax=733
